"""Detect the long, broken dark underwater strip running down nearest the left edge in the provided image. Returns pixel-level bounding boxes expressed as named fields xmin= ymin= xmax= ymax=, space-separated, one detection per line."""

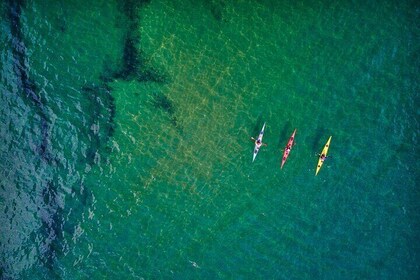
xmin=6 ymin=0 xmax=63 ymax=271
